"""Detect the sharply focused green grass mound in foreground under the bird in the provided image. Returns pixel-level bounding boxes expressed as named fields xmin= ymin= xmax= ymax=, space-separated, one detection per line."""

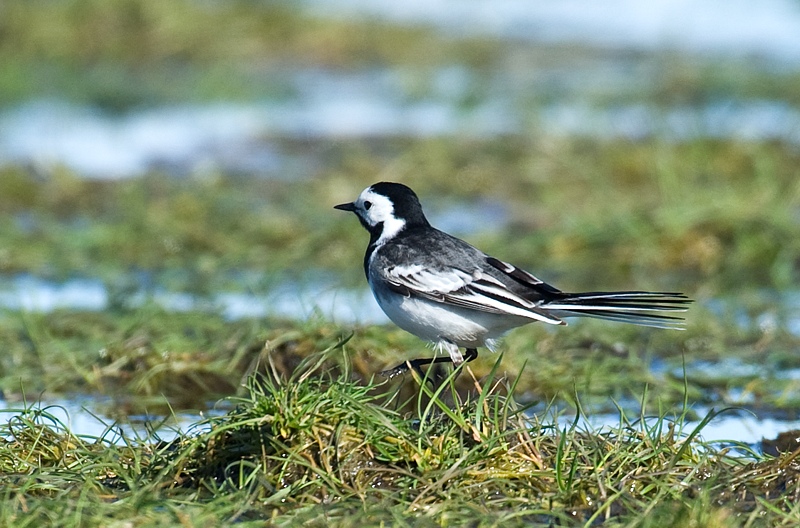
xmin=0 ymin=341 xmax=800 ymax=527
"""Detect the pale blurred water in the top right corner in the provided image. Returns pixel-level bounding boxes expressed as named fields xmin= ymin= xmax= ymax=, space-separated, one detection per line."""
xmin=305 ymin=0 xmax=800 ymax=62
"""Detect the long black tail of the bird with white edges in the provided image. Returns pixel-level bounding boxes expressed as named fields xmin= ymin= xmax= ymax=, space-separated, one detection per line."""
xmin=542 ymin=291 xmax=693 ymax=329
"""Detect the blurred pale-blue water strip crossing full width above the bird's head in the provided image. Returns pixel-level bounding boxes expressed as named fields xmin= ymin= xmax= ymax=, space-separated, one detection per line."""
xmin=0 ymin=98 xmax=800 ymax=179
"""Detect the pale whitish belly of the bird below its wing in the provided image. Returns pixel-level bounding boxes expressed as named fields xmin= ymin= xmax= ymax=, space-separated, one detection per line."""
xmin=375 ymin=292 xmax=531 ymax=348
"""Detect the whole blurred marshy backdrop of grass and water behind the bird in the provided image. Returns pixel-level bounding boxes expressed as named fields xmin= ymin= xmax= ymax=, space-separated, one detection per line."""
xmin=0 ymin=0 xmax=800 ymax=441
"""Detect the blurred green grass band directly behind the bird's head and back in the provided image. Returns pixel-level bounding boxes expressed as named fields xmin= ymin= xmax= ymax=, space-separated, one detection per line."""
xmin=0 ymin=138 xmax=800 ymax=295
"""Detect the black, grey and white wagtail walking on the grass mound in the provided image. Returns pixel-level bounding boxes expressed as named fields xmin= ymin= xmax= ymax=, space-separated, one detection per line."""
xmin=335 ymin=182 xmax=692 ymax=378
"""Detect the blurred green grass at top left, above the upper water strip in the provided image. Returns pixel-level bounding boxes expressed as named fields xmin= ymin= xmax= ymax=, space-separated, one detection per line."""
xmin=0 ymin=0 xmax=499 ymax=111
